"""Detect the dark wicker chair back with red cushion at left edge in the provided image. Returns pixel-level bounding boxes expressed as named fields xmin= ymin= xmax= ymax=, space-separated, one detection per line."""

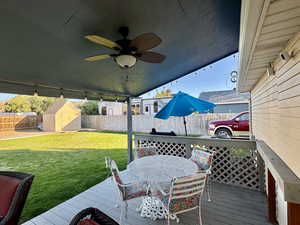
xmin=0 ymin=171 xmax=34 ymax=225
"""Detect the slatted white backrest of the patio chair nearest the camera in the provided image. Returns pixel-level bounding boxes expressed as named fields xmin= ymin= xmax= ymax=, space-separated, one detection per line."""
xmin=168 ymin=172 xmax=207 ymax=214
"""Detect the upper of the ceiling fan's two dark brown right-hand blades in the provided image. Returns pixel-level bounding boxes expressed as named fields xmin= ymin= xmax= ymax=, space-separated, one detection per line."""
xmin=130 ymin=33 xmax=161 ymax=52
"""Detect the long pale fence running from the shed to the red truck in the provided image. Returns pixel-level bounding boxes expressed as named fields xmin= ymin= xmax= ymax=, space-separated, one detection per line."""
xmin=81 ymin=113 xmax=235 ymax=135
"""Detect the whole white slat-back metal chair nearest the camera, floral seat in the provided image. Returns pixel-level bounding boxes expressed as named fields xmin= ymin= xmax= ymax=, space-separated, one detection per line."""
xmin=158 ymin=172 xmax=207 ymax=225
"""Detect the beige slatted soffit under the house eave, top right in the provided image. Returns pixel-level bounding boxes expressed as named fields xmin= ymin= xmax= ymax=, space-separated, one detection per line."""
xmin=238 ymin=0 xmax=300 ymax=92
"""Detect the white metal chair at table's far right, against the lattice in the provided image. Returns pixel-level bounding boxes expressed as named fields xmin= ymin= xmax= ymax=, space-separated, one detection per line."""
xmin=190 ymin=148 xmax=215 ymax=202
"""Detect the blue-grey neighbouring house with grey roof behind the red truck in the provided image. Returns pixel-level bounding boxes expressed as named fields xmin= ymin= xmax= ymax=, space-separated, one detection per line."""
xmin=199 ymin=89 xmax=250 ymax=113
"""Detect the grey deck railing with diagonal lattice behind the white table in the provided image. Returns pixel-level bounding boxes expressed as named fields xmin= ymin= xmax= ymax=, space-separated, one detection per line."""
xmin=135 ymin=135 xmax=265 ymax=191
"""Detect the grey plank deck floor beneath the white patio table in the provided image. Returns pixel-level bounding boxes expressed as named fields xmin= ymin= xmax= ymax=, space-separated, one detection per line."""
xmin=23 ymin=171 xmax=270 ymax=225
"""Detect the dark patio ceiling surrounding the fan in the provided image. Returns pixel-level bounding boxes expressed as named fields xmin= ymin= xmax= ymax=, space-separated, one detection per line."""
xmin=0 ymin=0 xmax=241 ymax=100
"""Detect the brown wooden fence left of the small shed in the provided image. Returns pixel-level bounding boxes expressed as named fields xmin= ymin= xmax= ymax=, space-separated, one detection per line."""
xmin=0 ymin=115 xmax=40 ymax=131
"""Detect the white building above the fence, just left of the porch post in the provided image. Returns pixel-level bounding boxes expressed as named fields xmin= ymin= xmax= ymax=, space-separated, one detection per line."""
xmin=98 ymin=101 xmax=127 ymax=116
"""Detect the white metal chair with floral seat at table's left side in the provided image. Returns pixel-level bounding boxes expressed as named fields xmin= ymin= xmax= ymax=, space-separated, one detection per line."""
xmin=110 ymin=160 xmax=148 ymax=225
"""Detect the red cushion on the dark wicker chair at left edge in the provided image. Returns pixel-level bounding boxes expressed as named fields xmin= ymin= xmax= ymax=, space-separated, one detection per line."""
xmin=0 ymin=175 xmax=21 ymax=217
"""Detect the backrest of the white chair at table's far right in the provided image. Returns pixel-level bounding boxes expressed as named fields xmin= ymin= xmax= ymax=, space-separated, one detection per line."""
xmin=190 ymin=149 xmax=214 ymax=170
